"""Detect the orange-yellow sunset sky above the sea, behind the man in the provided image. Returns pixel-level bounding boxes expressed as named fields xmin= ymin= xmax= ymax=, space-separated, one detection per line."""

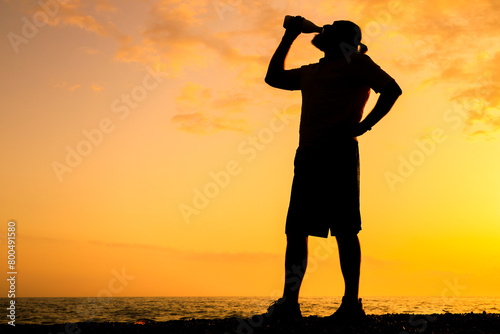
xmin=0 ymin=0 xmax=500 ymax=296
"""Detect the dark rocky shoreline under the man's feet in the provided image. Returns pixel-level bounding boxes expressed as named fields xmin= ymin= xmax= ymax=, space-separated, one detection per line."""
xmin=0 ymin=313 xmax=500 ymax=334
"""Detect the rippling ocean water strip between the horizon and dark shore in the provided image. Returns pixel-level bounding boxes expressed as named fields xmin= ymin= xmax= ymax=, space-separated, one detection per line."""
xmin=0 ymin=297 xmax=500 ymax=324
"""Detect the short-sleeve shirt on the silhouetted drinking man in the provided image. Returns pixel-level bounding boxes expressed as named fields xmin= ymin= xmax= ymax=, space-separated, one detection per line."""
xmin=287 ymin=53 xmax=394 ymax=146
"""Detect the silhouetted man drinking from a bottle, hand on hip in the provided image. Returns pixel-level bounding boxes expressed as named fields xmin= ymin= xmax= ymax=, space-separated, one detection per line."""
xmin=264 ymin=16 xmax=402 ymax=321
